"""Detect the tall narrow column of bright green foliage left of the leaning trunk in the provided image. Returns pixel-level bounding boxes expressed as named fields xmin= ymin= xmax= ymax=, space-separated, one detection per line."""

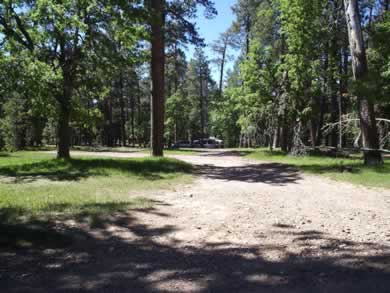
xmin=279 ymin=0 xmax=324 ymax=116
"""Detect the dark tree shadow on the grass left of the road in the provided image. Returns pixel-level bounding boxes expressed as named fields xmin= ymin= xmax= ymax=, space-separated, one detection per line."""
xmin=0 ymin=158 xmax=191 ymax=182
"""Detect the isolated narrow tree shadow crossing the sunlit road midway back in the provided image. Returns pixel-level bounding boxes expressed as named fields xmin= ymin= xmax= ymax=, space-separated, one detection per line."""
xmin=194 ymin=163 xmax=302 ymax=185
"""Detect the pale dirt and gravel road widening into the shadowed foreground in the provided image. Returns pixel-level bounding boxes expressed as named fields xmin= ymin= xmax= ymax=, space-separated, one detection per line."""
xmin=0 ymin=150 xmax=390 ymax=292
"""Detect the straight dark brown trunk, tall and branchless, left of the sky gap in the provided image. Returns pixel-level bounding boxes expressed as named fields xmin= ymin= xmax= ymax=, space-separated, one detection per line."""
xmin=151 ymin=0 xmax=165 ymax=157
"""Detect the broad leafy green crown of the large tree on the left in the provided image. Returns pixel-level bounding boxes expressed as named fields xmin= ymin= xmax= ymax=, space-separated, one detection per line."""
xmin=0 ymin=0 xmax=146 ymax=151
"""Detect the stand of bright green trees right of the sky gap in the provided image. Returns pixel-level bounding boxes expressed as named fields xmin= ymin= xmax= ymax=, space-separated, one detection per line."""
xmin=229 ymin=0 xmax=389 ymax=150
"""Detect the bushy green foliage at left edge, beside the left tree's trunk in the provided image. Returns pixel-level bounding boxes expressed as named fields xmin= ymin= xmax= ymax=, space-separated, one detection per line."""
xmin=0 ymin=55 xmax=56 ymax=150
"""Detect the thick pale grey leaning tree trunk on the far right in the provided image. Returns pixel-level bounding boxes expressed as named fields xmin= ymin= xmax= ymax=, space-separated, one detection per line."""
xmin=344 ymin=0 xmax=383 ymax=165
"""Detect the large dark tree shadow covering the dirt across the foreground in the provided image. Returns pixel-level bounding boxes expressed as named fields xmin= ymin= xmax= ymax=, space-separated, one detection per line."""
xmin=0 ymin=202 xmax=390 ymax=293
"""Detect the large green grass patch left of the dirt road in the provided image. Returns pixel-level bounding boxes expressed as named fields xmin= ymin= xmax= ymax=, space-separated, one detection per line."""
xmin=0 ymin=152 xmax=191 ymax=224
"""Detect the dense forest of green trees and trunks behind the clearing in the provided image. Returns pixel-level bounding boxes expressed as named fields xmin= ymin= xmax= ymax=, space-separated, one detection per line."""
xmin=0 ymin=0 xmax=390 ymax=164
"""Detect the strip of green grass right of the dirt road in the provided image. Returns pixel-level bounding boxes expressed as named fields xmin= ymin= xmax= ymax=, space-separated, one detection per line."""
xmin=245 ymin=149 xmax=390 ymax=188
